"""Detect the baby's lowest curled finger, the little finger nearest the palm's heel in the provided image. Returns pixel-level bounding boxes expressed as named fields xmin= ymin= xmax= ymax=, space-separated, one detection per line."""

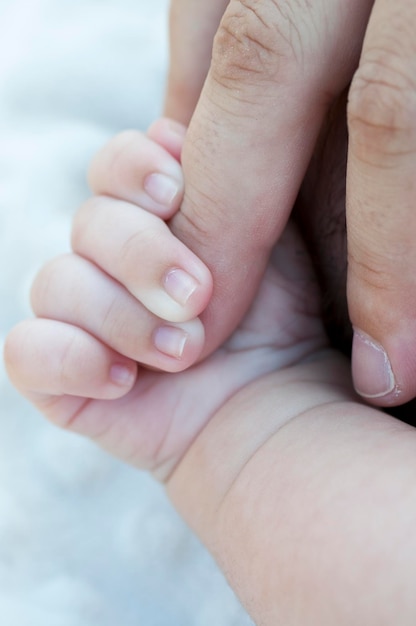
xmin=4 ymin=318 xmax=137 ymax=400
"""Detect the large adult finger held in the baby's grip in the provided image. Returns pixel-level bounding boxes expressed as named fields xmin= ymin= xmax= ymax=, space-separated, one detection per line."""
xmin=172 ymin=0 xmax=372 ymax=354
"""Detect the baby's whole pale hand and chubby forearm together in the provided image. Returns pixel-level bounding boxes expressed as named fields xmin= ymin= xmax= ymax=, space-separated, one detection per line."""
xmin=5 ymin=120 xmax=416 ymax=626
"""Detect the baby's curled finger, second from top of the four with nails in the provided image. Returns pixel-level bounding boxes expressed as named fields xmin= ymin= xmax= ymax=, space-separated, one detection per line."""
xmin=72 ymin=197 xmax=212 ymax=322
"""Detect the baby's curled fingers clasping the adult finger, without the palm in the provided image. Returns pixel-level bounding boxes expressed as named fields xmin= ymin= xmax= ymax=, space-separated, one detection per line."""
xmin=5 ymin=119 xmax=212 ymax=400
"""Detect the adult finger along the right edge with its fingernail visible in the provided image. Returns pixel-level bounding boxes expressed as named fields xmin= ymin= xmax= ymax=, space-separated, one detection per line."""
xmin=347 ymin=0 xmax=416 ymax=406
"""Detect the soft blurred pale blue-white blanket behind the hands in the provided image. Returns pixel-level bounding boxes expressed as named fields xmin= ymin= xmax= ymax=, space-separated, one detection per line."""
xmin=0 ymin=0 xmax=251 ymax=626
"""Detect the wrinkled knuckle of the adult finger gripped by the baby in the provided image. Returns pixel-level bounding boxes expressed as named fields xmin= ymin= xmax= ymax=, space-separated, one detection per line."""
xmin=212 ymin=0 xmax=298 ymax=88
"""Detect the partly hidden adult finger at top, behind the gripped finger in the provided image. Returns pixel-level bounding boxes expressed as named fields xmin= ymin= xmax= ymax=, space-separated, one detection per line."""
xmin=165 ymin=0 xmax=229 ymax=124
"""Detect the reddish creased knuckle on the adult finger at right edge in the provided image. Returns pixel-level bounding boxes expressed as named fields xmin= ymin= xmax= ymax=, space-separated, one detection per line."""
xmin=348 ymin=51 xmax=416 ymax=166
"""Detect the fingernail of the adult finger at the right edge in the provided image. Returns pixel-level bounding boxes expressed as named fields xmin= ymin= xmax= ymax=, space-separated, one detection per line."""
xmin=352 ymin=329 xmax=396 ymax=398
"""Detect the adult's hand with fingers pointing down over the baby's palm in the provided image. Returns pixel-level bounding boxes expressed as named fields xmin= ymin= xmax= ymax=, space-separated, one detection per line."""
xmin=167 ymin=0 xmax=416 ymax=405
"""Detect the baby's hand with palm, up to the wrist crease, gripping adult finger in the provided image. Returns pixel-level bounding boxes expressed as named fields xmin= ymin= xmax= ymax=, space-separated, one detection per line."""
xmin=5 ymin=120 xmax=328 ymax=484
